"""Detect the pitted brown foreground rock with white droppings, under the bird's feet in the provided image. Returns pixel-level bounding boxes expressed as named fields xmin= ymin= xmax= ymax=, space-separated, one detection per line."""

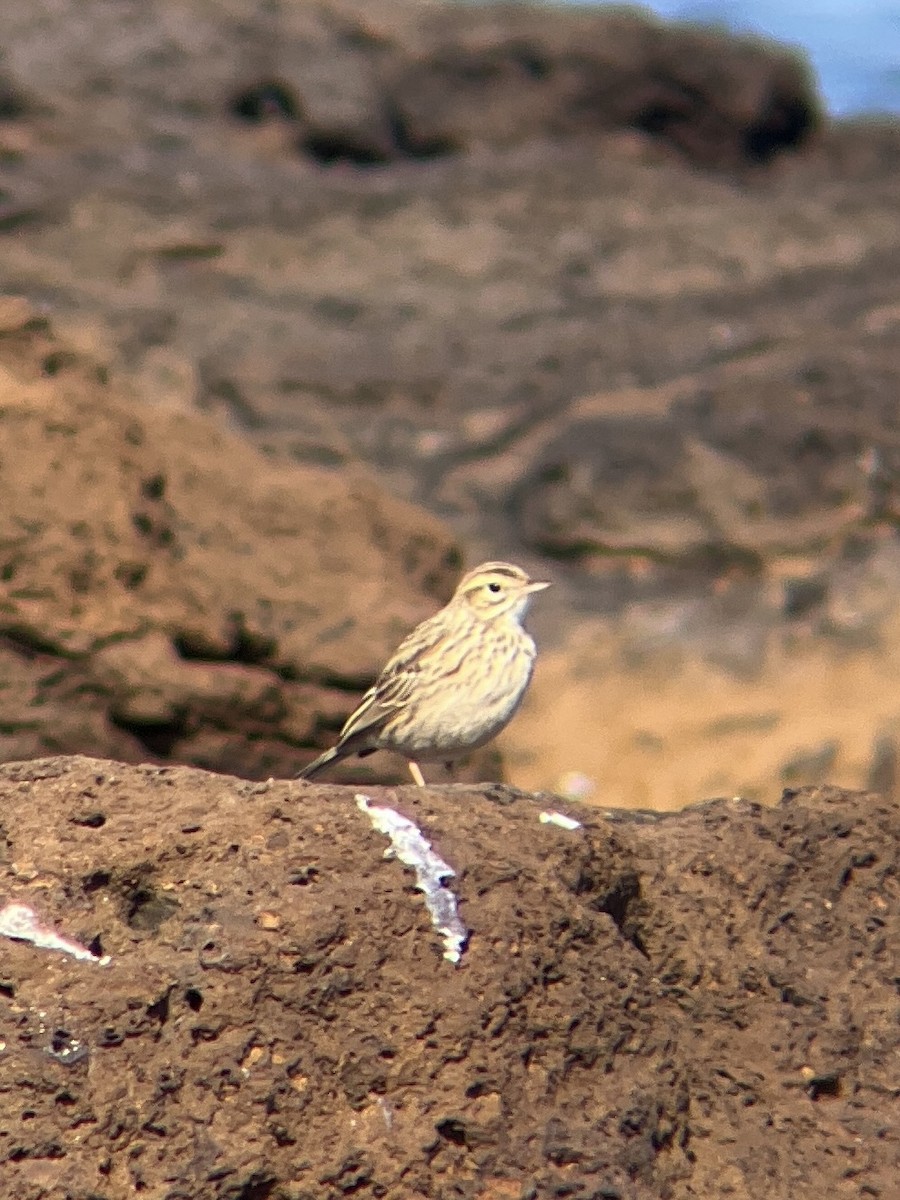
xmin=0 ymin=758 xmax=900 ymax=1200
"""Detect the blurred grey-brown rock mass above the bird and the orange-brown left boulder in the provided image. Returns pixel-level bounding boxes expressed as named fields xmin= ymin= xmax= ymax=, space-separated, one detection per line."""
xmin=0 ymin=0 xmax=900 ymax=597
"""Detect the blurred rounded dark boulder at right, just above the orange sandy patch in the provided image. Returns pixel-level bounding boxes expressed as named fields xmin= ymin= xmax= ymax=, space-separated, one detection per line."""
xmin=506 ymin=346 xmax=900 ymax=576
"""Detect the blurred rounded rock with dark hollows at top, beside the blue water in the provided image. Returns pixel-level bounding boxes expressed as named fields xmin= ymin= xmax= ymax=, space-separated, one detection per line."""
xmin=382 ymin=5 xmax=821 ymax=167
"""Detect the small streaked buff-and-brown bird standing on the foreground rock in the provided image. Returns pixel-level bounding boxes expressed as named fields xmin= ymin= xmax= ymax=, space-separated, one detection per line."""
xmin=296 ymin=563 xmax=550 ymax=787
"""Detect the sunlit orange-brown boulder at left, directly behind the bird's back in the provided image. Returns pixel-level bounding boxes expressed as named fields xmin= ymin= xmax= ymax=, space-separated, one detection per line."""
xmin=0 ymin=302 xmax=460 ymax=776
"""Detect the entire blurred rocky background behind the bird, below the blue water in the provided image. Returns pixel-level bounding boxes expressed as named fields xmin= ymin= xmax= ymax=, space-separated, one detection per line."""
xmin=0 ymin=0 xmax=900 ymax=808
